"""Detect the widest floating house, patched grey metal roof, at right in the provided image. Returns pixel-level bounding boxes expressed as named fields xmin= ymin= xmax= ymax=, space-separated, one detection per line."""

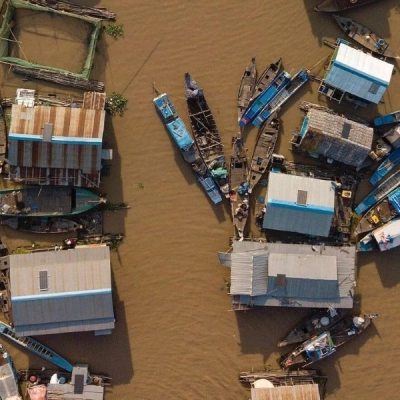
xmin=218 ymin=241 xmax=356 ymax=310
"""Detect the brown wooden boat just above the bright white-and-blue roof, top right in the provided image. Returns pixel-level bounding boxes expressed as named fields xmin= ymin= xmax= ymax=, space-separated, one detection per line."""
xmin=333 ymin=15 xmax=400 ymax=58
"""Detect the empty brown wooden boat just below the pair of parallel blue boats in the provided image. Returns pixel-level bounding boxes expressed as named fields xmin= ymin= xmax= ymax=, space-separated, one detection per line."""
xmin=248 ymin=113 xmax=279 ymax=193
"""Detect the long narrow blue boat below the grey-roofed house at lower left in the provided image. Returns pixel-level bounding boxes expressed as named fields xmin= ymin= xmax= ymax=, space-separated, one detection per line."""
xmin=0 ymin=321 xmax=73 ymax=372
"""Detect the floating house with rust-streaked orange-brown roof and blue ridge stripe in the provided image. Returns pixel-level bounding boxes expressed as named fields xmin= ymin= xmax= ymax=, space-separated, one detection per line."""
xmin=7 ymin=89 xmax=112 ymax=188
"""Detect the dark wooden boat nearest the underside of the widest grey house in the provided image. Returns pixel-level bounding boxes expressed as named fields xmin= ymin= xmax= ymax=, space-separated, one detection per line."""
xmin=278 ymin=308 xmax=343 ymax=347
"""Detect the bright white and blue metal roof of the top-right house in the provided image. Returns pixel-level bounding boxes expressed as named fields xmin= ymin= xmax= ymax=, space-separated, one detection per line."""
xmin=325 ymin=43 xmax=393 ymax=104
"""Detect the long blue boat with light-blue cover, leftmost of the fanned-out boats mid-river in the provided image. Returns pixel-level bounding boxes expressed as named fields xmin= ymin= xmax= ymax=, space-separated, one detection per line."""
xmin=153 ymin=93 xmax=222 ymax=204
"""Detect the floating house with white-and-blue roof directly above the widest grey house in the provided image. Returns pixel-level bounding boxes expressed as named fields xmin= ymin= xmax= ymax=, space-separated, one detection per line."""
xmin=263 ymin=172 xmax=335 ymax=237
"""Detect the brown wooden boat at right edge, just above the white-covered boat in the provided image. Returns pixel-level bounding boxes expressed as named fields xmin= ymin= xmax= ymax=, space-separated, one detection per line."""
xmin=352 ymin=188 xmax=400 ymax=238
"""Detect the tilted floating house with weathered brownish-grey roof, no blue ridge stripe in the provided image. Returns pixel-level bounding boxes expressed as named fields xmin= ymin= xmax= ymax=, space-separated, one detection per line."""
xmin=291 ymin=108 xmax=374 ymax=168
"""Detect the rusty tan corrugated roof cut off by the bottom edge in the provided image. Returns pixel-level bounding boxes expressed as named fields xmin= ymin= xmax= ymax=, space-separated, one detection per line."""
xmin=251 ymin=383 xmax=321 ymax=400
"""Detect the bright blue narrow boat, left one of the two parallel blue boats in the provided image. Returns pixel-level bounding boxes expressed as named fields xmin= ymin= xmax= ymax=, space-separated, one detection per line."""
xmin=239 ymin=71 xmax=292 ymax=128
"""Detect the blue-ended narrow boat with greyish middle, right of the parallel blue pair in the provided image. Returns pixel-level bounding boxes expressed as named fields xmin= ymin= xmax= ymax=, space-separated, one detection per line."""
xmin=252 ymin=69 xmax=310 ymax=126
